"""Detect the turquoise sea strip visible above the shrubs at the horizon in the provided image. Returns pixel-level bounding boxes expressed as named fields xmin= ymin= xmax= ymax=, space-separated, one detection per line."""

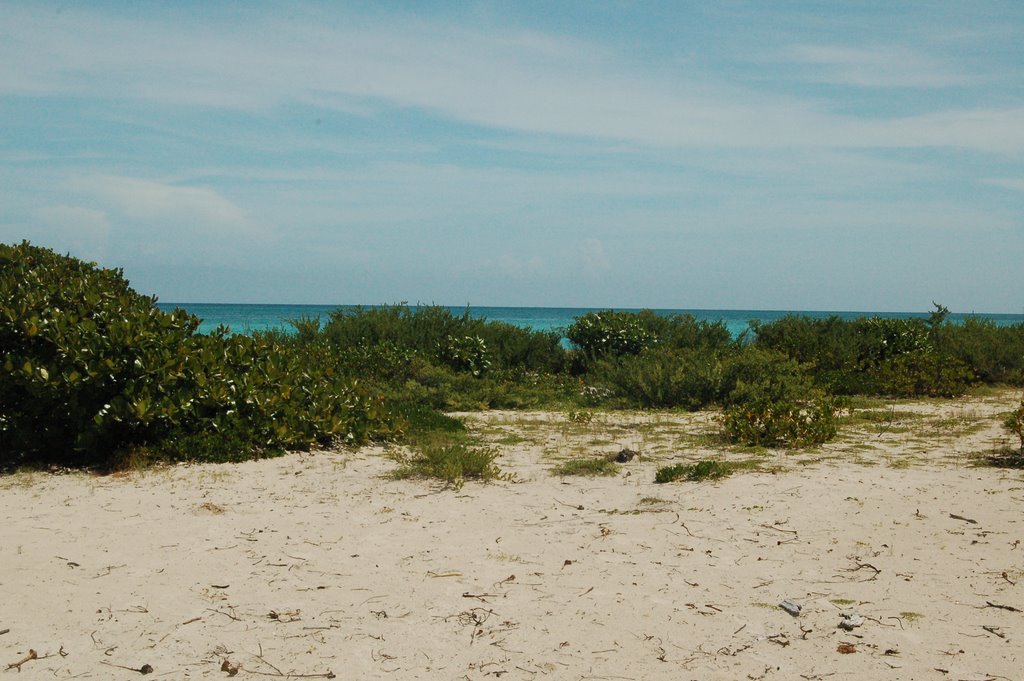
xmin=158 ymin=303 xmax=1024 ymax=336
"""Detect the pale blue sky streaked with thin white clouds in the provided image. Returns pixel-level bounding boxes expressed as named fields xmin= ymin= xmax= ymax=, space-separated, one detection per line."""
xmin=0 ymin=0 xmax=1024 ymax=313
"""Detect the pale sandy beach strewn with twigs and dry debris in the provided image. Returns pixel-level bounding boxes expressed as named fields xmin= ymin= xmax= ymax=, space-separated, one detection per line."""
xmin=0 ymin=391 xmax=1024 ymax=680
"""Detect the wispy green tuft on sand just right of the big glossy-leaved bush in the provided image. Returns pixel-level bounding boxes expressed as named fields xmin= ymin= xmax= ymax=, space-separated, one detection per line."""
xmin=391 ymin=440 xmax=513 ymax=490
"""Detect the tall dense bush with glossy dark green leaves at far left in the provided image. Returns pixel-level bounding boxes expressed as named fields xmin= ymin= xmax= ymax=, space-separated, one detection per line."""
xmin=0 ymin=243 xmax=392 ymax=465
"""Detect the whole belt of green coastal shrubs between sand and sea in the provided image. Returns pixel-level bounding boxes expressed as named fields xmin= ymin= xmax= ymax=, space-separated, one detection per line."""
xmin=0 ymin=243 xmax=1024 ymax=473
